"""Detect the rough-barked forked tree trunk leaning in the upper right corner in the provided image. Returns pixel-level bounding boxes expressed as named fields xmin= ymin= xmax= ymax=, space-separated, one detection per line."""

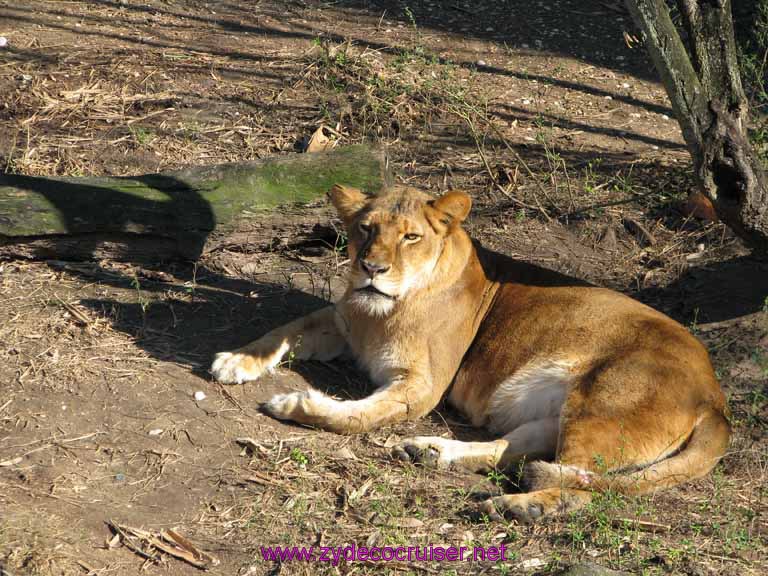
xmin=625 ymin=0 xmax=768 ymax=254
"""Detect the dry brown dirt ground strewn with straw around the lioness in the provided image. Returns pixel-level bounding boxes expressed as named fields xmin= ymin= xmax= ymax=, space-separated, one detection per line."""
xmin=0 ymin=0 xmax=768 ymax=576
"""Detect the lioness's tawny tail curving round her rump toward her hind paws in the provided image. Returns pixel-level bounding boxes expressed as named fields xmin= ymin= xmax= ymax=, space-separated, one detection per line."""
xmin=523 ymin=408 xmax=731 ymax=494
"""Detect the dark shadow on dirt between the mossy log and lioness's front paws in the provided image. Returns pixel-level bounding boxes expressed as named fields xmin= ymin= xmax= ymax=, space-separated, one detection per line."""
xmin=74 ymin=264 xmax=329 ymax=379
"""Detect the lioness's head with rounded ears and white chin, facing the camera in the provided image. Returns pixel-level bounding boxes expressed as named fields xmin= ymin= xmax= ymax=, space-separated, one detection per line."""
xmin=330 ymin=184 xmax=472 ymax=316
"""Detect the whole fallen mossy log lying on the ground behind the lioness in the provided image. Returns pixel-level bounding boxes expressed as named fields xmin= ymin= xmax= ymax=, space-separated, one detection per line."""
xmin=0 ymin=146 xmax=388 ymax=262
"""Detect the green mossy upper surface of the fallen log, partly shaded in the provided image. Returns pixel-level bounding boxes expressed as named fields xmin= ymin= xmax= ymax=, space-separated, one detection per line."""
xmin=0 ymin=146 xmax=384 ymax=237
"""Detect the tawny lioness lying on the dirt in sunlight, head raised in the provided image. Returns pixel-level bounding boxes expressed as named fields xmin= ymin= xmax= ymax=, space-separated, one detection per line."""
xmin=211 ymin=185 xmax=730 ymax=522
